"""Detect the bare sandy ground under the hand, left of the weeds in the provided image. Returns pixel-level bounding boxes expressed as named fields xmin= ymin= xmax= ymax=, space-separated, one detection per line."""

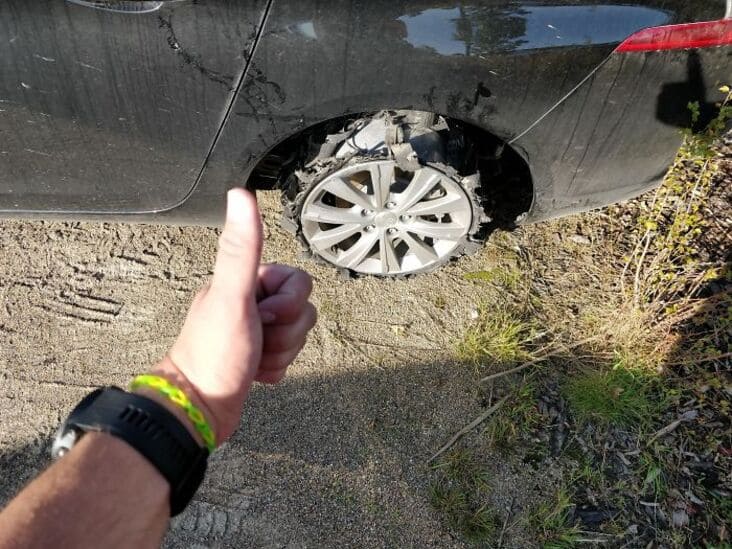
xmin=0 ymin=193 xmax=558 ymax=548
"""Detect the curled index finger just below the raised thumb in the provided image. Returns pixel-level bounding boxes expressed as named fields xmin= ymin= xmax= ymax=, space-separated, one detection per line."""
xmin=259 ymin=265 xmax=313 ymax=324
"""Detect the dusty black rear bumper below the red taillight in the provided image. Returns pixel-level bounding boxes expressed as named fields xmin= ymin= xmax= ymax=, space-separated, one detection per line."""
xmin=513 ymin=47 xmax=732 ymax=222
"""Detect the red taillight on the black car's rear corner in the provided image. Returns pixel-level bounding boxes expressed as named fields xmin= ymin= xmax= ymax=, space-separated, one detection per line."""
xmin=616 ymin=19 xmax=732 ymax=52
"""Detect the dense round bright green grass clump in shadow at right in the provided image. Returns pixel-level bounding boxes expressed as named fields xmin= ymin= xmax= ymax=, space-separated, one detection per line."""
xmin=564 ymin=358 xmax=663 ymax=426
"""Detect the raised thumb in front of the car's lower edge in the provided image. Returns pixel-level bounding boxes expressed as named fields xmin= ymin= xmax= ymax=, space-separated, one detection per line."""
xmin=211 ymin=189 xmax=262 ymax=299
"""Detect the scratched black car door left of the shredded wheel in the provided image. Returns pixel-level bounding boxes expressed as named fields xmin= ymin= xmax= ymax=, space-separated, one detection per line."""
xmin=0 ymin=0 xmax=266 ymax=213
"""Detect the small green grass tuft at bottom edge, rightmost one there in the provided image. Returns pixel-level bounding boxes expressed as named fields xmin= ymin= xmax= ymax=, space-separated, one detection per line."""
xmin=529 ymin=489 xmax=579 ymax=549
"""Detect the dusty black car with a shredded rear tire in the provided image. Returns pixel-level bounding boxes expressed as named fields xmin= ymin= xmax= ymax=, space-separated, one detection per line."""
xmin=0 ymin=0 xmax=732 ymax=275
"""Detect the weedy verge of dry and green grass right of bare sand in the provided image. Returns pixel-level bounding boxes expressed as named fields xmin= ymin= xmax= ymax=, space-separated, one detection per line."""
xmin=428 ymin=90 xmax=732 ymax=547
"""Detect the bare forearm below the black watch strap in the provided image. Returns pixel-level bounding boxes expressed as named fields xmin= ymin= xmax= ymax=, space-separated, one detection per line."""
xmin=0 ymin=433 xmax=170 ymax=549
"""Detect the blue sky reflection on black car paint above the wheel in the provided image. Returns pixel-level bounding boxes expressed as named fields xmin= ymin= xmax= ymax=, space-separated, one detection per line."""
xmin=398 ymin=5 xmax=672 ymax=55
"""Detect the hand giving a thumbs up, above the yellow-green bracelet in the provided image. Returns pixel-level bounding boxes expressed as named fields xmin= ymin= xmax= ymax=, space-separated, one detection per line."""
xmin=148 ymin=189 xmax=317 ymax=444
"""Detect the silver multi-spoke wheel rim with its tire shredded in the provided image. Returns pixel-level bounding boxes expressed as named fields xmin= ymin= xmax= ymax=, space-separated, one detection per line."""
xmin=301 ymin=160 xmax=473 ymax=275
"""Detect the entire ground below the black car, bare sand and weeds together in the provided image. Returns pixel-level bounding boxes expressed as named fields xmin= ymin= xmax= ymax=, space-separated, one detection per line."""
xmin=0 ymin=157 xmax=732 ymax=548
